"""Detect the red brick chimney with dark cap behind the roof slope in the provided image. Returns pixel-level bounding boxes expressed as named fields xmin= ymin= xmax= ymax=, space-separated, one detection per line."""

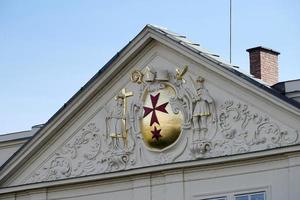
xmin=247 ymin=46 xmax=280 ymax=85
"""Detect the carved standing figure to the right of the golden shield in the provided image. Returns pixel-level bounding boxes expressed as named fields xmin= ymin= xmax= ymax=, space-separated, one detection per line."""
xmin=193 ymin=76 xmax=214 ymax=133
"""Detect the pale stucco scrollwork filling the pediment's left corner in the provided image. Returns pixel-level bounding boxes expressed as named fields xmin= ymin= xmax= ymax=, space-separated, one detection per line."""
xmin=24 ymin=123 xmax=101 ymax=183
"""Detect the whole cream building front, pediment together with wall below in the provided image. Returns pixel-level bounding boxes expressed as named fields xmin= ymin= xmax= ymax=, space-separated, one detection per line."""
xmin=0 ymin=25 xmax=300 ymax=200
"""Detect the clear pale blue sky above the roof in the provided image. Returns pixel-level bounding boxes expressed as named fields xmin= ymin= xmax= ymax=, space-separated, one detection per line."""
xmin=0 ymin=0 xmax=300 ymax=133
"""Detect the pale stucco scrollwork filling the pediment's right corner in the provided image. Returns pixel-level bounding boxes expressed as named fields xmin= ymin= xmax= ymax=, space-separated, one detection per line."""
xmin=208 ymin=100 xmax=299 ymax=156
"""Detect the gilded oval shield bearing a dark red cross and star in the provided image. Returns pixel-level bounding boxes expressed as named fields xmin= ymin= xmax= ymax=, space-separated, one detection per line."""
xmin=141 ymin=85 xmax=183 ymax=151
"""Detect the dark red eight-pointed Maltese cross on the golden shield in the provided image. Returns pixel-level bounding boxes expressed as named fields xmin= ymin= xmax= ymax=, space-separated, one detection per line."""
xmin=144 ymin=93 xmax=169 ymax=126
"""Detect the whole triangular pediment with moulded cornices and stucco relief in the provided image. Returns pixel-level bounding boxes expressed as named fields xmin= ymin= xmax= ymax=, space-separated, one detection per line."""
xmin=0 ymin=26 xmax=300 ymax=186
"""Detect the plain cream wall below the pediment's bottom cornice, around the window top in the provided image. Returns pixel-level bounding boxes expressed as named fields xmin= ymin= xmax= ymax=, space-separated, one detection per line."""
xmin=0 ymin=153 xmax=300 ymax=200
